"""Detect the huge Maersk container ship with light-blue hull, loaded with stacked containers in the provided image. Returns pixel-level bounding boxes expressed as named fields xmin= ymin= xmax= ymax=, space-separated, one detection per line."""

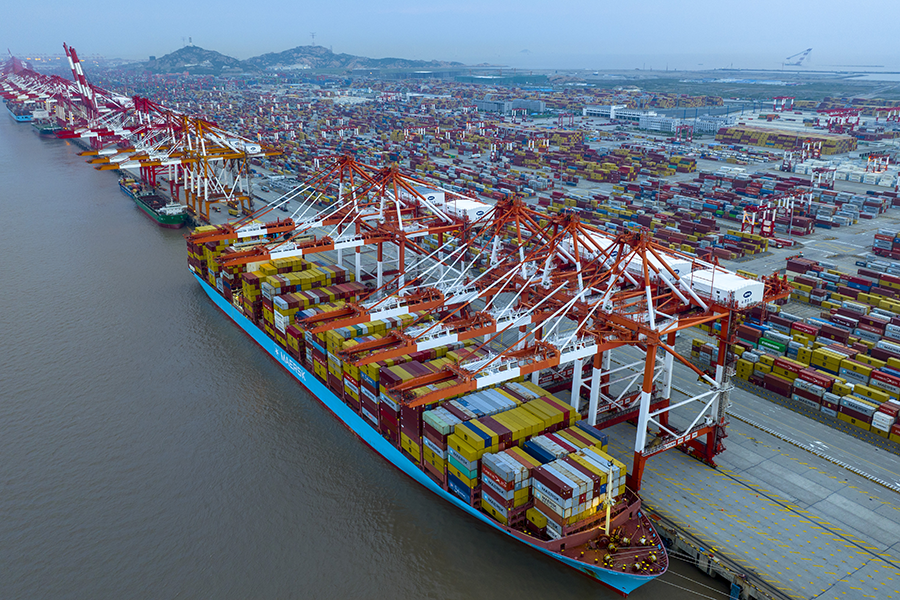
xmin=188 ymin=237 xmax=668 ymax=595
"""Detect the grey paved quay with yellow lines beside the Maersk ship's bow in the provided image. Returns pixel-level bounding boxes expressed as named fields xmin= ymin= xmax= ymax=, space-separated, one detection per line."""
xmin=568 ymin=302 xmax=900 ymax=599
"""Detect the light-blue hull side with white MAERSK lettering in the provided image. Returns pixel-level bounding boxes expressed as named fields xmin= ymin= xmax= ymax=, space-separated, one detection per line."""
xmin=191 ymin=271 xmax=658 ymax=595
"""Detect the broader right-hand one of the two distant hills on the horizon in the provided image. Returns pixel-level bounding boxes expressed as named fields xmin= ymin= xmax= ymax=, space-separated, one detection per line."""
xmin=245 ymin=46 xmax=462 ymax=71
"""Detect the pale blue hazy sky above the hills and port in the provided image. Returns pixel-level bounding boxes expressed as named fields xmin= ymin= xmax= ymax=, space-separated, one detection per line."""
xmin=7 ymin=0 xmax=900 ymax=70
